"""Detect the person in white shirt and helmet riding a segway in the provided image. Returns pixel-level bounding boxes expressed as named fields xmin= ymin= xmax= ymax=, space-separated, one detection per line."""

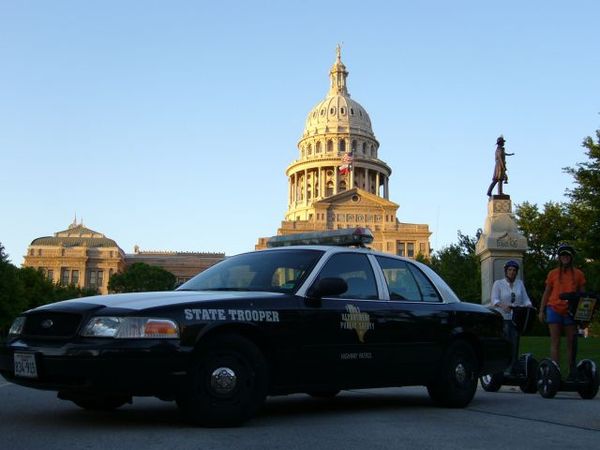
xmin=491 ymin=260 xmax=532 ymax=366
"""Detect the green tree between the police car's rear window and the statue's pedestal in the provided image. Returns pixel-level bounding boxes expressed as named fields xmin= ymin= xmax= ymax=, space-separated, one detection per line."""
xmin=425 ymin=231 xmax=481 ymax=303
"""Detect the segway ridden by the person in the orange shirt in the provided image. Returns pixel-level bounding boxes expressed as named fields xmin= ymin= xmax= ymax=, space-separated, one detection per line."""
xmin=537 ymin=292 xmax=600 ymax=400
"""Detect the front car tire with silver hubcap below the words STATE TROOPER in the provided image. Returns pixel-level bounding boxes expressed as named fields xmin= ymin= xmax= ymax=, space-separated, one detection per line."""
xmin=176 ymin=335 xmax=268 ymax=427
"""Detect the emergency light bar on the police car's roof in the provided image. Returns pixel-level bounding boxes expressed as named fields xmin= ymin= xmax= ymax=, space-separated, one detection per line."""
xmin=267 ymin=228 xmax=373 ymax=248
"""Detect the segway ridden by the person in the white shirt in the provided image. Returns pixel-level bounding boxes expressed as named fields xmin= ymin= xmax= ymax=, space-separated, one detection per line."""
xmin=479 ymin=306 xmax=538 ymax=394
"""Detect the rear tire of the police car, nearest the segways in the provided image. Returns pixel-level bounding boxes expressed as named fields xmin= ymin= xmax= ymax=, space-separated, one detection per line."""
xmin=427 ymin=341 xmax=478 ymax=408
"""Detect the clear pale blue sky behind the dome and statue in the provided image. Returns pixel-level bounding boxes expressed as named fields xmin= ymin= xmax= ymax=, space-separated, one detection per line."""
xmin=0 ymin=0 xmax=600 ymax=265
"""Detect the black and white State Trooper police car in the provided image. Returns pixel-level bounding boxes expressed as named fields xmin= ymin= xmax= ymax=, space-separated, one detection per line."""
xmin=0 ymin=228 xmax=510 ymax=426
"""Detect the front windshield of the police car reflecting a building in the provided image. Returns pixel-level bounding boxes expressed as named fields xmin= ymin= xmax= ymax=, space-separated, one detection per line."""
xmin=177 ymin=249 xmax=323 ymax=293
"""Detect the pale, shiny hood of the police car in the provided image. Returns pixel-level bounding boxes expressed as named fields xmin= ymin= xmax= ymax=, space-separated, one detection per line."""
xmin=35 ymin=291 xmax=285 ymax=311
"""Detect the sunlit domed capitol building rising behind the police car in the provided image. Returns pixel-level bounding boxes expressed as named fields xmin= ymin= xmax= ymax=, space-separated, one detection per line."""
xmin=255 ymin=46 xmax=431 ymax=258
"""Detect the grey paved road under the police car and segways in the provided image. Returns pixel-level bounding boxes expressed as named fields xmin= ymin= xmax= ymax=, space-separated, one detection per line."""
xmin=0 ymin=378 xmax=600 ymax=450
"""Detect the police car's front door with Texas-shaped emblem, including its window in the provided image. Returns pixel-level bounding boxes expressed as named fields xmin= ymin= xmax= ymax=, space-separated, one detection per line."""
xmin=300 ymin=251 xmax=389 ymax=387
